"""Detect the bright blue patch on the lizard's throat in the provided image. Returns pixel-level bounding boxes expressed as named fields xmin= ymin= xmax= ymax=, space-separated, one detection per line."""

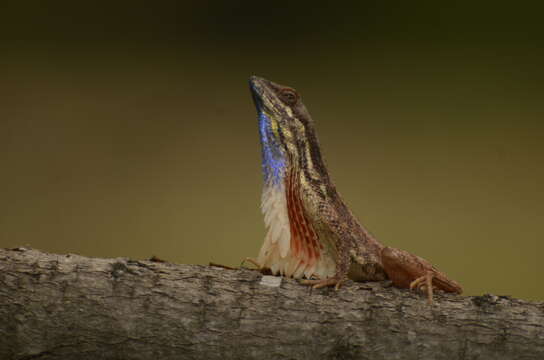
xmin=259 ymin=111 xmax=286 ymax=185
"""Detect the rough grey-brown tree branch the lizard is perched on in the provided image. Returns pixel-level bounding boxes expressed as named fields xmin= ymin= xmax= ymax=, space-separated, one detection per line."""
xmin=0 ymin=248 xmax=544 ymax=360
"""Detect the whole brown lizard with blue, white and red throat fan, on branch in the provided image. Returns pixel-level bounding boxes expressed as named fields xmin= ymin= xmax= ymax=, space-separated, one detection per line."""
xmin=250 ymin=76 xmax=461 ymax=304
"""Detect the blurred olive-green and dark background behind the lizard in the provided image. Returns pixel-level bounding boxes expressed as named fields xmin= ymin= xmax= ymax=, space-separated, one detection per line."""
xmin=0 ymin=1 xmax=544 ymax=300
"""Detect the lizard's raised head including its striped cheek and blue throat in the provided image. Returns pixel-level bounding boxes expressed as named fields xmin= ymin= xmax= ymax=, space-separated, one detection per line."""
xmin=249 ymin=76 xmax=317 ymax=183
